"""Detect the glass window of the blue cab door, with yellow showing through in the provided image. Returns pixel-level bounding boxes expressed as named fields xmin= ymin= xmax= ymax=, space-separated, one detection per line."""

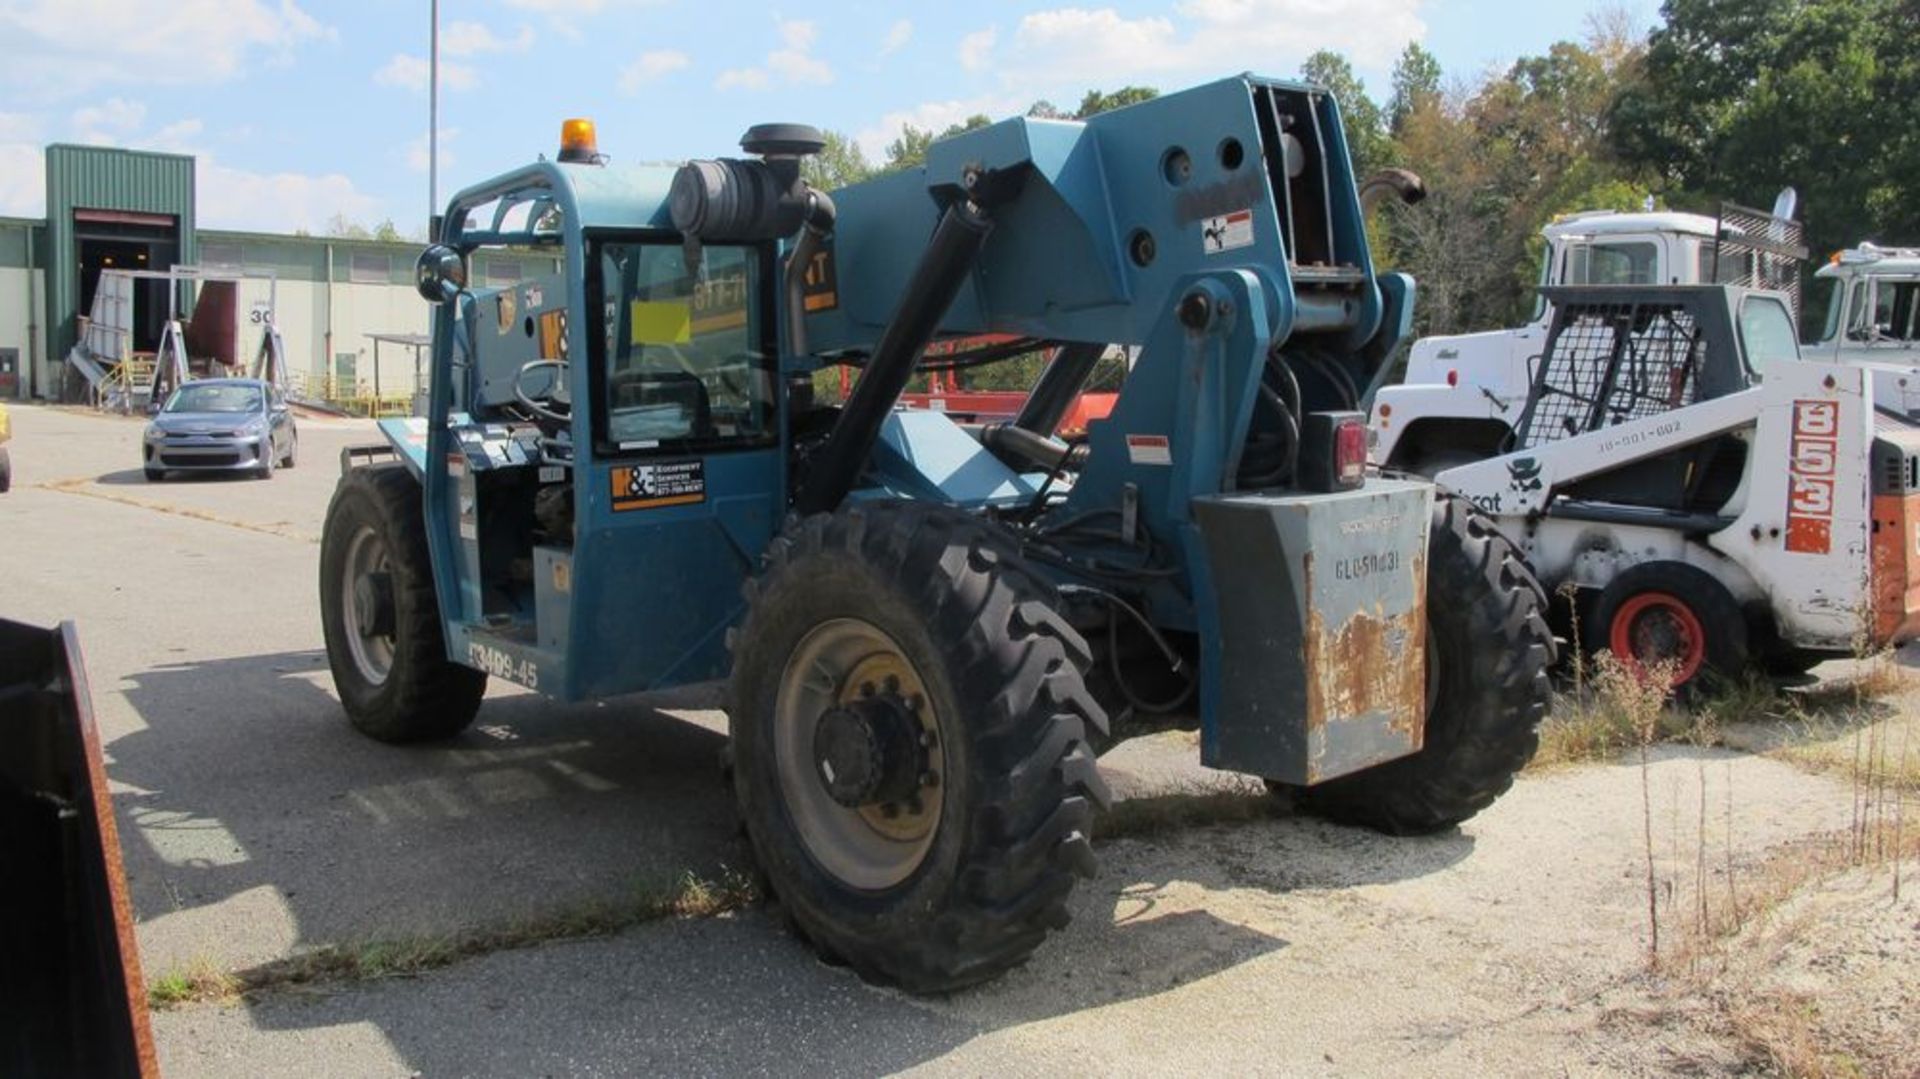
xmin=595 ymin=242 xmax=774 ymax=449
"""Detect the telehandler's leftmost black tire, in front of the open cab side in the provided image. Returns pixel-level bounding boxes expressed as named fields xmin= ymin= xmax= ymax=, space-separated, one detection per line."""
xmin=321 ymin=463 xmax=486 ymax=743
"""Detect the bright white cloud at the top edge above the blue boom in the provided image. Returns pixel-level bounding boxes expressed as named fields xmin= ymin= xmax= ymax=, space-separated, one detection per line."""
xmin=1002 ymin=0 xmax=1427 ymax=83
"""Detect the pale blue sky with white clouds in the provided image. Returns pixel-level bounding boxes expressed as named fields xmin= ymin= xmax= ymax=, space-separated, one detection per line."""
xmin=0 ymin=0 xmax=1655 ymax=232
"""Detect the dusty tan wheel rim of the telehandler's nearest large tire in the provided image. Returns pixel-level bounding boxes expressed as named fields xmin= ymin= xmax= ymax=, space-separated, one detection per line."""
xmin=774 ymin=618 xmax=947 ymax=891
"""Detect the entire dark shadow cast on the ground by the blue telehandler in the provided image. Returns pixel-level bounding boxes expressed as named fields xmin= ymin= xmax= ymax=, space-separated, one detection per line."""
xmin=123 ymin=653 xmax=1473 ymax=1073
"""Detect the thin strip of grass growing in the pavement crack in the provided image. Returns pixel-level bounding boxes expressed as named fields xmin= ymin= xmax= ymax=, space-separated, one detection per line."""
xmin=148 ymin=870 xmax=758 ymax=1008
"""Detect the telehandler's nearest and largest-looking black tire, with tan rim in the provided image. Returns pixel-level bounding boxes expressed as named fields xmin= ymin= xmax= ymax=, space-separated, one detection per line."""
xmin=728 ymin=503 xmax=1108 ymax=993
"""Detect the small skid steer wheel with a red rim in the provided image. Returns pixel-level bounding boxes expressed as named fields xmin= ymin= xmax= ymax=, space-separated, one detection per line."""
xmin=1582 ymin=563 xmax=1751 ymax=695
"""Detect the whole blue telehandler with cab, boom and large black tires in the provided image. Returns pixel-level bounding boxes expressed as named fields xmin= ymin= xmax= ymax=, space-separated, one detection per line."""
xmin=321 ymin=75 xmax=1553 ymax=993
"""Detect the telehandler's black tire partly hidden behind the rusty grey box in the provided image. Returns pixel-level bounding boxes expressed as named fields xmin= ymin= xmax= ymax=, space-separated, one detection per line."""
xmin=1290 ymin=495 xmax=1553 ymax=835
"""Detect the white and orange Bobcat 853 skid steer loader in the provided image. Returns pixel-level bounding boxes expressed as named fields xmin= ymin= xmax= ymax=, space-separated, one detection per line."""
xmin=1371 ymin=286 xmax=1920 ymax=687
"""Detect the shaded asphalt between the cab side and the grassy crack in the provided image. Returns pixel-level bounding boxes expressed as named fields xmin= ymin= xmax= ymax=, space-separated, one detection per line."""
xmin=108 ymin=651 xmax=745 ymax=956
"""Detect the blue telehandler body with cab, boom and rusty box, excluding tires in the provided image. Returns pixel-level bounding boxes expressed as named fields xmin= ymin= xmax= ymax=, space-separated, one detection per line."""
xmin=382 ymin=77 xmax=1432 ymax=781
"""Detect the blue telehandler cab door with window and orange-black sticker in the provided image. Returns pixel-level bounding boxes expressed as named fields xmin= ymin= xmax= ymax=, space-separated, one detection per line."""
xmin=570 ymin=234 xmax=785 ymax=695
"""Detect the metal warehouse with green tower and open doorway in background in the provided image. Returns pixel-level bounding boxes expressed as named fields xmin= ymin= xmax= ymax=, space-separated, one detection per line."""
xmin=0 ymin=144 xmax=530 ymax=399
